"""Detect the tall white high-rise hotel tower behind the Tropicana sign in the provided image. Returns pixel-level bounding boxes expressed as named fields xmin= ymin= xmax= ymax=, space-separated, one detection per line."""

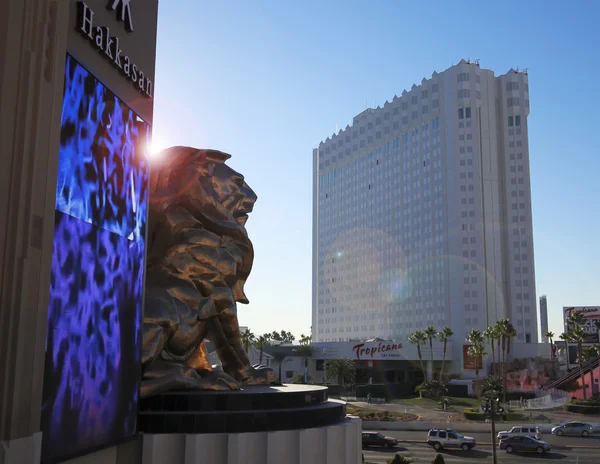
xmin=312 ymin=60 xmax=538 ymax=359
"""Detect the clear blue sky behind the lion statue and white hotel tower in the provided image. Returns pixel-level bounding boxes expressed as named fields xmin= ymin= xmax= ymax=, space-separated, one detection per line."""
xmin=153 ymin=0 xmax=600 ymax=337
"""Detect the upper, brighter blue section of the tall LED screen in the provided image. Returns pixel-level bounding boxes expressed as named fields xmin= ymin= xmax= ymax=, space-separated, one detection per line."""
xmin=56 ymin=56 xmax=150 ymax=240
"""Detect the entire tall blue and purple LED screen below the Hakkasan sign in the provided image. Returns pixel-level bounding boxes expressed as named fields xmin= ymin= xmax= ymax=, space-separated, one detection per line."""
xmin=41 ymin=56 xmax=150 ymax=462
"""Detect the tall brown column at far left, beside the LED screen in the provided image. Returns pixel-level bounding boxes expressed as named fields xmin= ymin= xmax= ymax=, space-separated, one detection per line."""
xmin=0 ymin=0 xmax=70 ymax=464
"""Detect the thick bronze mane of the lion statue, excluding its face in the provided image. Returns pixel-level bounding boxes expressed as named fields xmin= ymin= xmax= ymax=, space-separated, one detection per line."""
xmin=146 ymin=147 xmax=254 ymax=319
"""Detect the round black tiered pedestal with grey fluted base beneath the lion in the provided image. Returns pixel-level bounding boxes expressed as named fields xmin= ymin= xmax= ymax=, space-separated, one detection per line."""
xmin=139 ymin=385 xmax=362 ymax=464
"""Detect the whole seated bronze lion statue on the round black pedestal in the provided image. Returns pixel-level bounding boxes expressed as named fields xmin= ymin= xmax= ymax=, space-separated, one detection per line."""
xmin=141 ymin=147 xmax=276 ymax=397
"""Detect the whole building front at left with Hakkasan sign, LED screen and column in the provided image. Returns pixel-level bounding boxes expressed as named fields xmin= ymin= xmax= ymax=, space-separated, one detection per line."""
xmin=0 ymin=0 xmax=158 ymax=464
